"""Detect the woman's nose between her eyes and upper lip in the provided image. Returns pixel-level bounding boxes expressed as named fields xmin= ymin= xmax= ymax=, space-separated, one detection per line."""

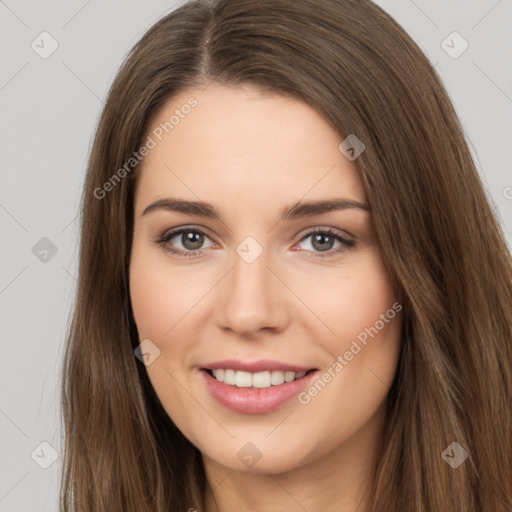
xmin=216 ymin=243 xmax=288 ymax=337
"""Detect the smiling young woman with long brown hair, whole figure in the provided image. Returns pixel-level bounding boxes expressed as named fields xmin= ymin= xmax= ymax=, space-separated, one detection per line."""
xmin=61 ymin=0 xmax=512 ymax=512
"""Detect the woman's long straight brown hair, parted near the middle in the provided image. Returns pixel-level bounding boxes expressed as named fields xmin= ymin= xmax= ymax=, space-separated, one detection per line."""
xmin=60 ymin=0 xmax=512 ymax=512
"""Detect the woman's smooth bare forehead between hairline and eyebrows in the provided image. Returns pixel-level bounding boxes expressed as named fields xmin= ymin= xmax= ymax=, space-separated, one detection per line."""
xmin=132 ymin=84 xmax=365 ymax=211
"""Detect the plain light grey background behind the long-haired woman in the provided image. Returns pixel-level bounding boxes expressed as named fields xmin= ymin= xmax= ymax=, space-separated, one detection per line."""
xmin=0 ymin=0 xmax=512 ymax=512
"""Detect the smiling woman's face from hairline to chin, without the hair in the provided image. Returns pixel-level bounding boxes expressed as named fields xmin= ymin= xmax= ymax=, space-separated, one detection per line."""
xmin=130 ymin=84 xmax=402 ymax=473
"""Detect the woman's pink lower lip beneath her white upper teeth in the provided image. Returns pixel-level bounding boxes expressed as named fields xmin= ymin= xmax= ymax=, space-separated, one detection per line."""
xmin=201 ymin=370 xmax=318 ymax=414
